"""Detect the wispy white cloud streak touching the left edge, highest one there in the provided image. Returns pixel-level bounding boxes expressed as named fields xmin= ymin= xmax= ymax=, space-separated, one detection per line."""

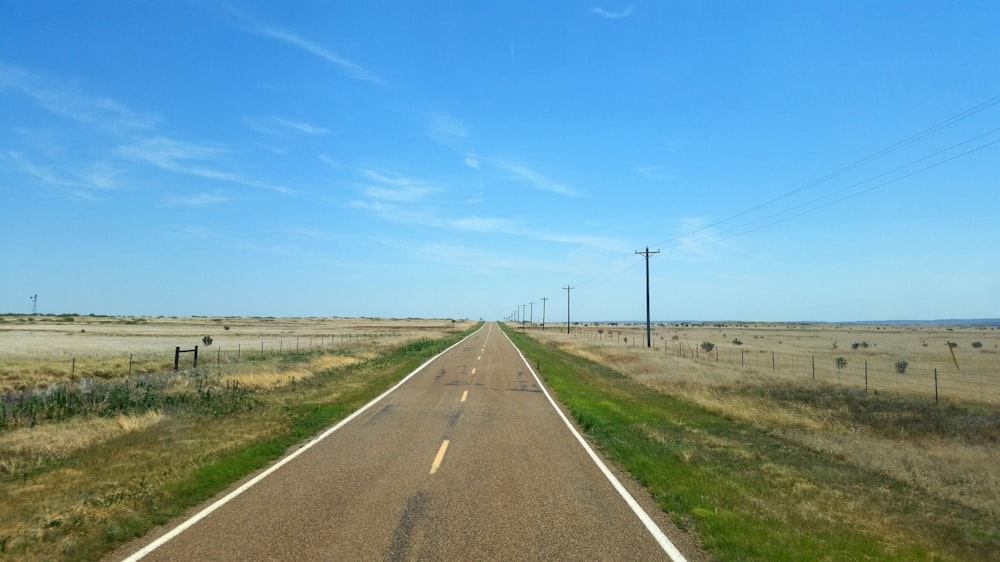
xmin=0 ymin=63 xmax=158 ymax=134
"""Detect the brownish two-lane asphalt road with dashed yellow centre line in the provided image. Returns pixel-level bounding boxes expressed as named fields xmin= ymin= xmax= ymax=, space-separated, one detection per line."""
xmin=115 ymin=323 xmax=696 ymax=561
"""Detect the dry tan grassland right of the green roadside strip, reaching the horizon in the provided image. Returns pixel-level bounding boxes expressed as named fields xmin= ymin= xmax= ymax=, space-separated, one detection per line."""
xmin=527 ymin=323 xmax=1000 ymax=532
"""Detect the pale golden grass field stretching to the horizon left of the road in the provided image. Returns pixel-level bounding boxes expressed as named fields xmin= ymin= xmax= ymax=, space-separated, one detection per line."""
xmin=0 ymin=315 xmax=468 ymax=392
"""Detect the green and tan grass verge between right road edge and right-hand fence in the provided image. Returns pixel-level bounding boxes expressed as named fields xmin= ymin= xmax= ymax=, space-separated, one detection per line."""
xmin=507 ymin=329 xmax=1000 ymax=561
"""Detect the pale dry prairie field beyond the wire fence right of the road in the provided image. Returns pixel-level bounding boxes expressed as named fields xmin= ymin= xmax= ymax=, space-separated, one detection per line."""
xmin=529 ymin=323 xmax=1000 ymax=405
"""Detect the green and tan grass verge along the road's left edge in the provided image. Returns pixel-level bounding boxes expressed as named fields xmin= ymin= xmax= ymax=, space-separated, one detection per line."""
xmin=0 ymin=327 xmax=475 ymax=561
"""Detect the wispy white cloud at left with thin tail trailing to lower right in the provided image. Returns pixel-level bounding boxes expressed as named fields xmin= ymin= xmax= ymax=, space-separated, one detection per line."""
xmin=115 ymin=136 xmax=291 ymax=193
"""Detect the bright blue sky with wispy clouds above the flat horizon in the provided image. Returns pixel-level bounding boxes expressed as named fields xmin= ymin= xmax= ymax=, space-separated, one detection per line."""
xmin=0 ymin=0 xmax=1000 ymax=323
